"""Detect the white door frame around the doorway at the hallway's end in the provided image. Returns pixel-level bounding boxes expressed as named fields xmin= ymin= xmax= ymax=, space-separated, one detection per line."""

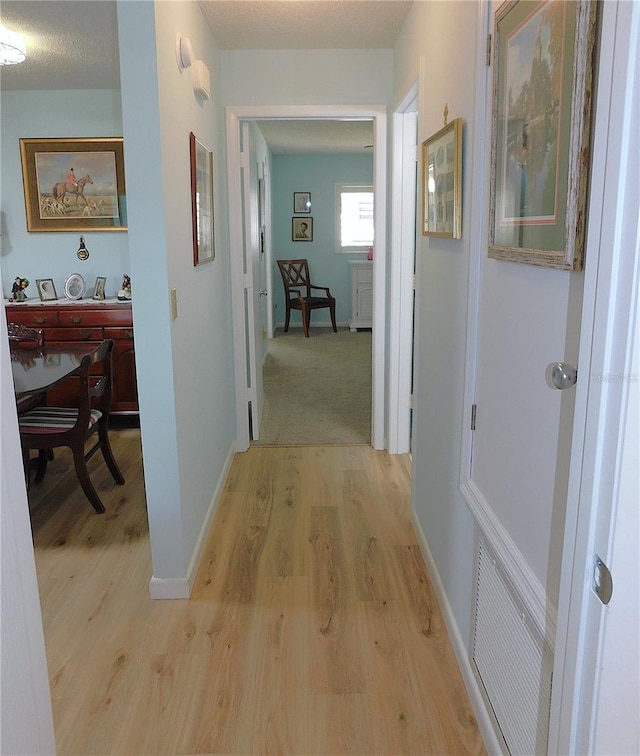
xmin=226 ymin=105 xmax=387 ymax=451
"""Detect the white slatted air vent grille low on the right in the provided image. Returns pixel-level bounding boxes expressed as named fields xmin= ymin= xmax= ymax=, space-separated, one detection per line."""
xmin=473 ymin=540 xmax=553 ymax=756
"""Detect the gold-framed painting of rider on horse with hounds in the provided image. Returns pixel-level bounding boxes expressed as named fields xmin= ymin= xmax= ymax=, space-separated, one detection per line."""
xmin=20 ymin=137 xmax=127 ymax=231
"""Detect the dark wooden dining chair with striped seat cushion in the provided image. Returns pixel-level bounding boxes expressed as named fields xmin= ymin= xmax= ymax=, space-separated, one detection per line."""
xmin=18 ymin=339 xmax=124 ymax=513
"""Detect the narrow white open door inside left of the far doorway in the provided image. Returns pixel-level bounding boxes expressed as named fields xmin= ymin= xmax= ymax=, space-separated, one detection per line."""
xmin=241 ymin=122 xmax=266 ymax=441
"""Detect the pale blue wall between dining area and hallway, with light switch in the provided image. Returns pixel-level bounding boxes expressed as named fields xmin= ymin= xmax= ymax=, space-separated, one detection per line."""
xmin=118 ymin=2 xmax=235 ymax=595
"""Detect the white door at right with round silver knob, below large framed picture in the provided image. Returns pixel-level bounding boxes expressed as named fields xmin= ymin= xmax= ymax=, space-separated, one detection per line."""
xmin=463 ymin=2 xmax=598 ymax=752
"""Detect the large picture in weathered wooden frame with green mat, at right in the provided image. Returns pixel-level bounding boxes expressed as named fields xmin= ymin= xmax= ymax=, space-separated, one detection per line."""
xmin=489 ymin=0 xmax=598 ymax=270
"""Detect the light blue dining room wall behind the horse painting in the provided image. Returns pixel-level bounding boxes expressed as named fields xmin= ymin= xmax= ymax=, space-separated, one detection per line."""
xmin=0 ymin=89 xmax=127 ymax=300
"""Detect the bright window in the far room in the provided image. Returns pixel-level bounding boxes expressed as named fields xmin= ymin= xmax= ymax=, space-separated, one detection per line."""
xmin=336 ymin=184 xmax=373 ymax=252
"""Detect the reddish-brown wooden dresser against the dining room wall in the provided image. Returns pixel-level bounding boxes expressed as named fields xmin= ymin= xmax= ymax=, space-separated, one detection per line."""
xmin=5 ymin=300 xmax=138 ymax=414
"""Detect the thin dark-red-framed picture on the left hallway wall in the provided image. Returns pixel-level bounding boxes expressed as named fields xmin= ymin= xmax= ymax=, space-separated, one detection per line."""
xmin=189 ymin=132 xmax=216 ymax=265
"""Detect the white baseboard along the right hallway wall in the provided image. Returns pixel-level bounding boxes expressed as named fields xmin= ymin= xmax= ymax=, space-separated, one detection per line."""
xmin=411 ymin=511 xmax=504 ymax=755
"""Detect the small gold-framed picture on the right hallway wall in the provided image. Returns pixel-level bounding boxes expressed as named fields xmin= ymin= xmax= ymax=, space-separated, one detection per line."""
xmin=422 ymin=118 xmax=462 ymax=239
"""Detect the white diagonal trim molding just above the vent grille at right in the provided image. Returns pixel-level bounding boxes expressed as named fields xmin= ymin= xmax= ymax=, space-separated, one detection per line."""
xmin=460 ymin=480 xmax=558 ymax=650
